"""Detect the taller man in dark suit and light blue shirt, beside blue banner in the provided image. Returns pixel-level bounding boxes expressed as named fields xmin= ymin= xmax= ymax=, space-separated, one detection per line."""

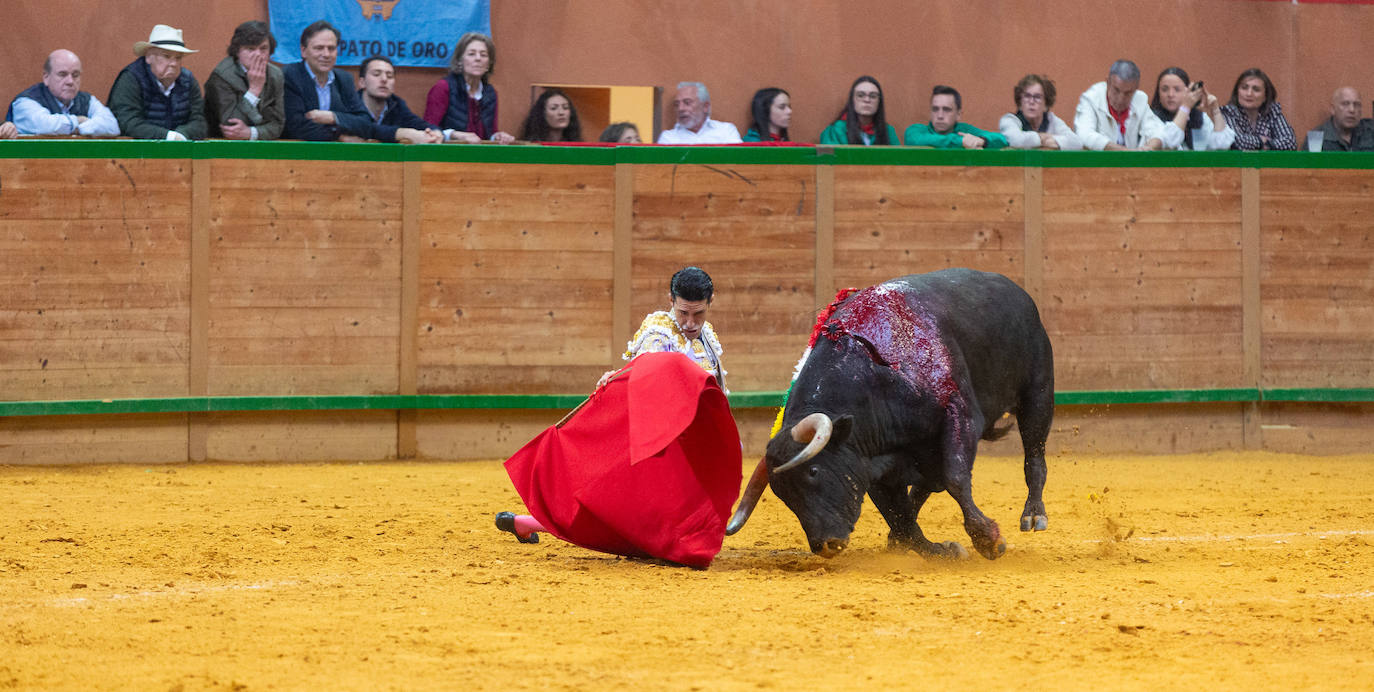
xmin=282 ymin=19 xmax=434 ymax=141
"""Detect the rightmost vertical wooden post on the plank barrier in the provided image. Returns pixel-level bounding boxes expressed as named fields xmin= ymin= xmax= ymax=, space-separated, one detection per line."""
xmin=1241 ymin=169 xmax=1264 ymax=449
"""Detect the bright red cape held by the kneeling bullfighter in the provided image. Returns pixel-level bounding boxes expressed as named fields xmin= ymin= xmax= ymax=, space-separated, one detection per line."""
xmin=506 ymin=353 xmax=742 ymax=568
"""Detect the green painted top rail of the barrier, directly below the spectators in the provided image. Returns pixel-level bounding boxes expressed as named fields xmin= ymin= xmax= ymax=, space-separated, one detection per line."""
xmin=8 ymin=139 xmax=1374 ymax=169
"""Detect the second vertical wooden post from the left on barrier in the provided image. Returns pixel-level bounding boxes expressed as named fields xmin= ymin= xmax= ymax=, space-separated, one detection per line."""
xmin=396 ymin=161 xmax=423 ymax=459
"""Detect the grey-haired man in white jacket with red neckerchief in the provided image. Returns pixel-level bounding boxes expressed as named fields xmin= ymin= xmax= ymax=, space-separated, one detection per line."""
xmin=1073 ymin=60 xmax=1164 ymax=151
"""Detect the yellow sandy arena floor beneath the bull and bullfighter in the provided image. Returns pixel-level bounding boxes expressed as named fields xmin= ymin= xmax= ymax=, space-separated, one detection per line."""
xmin=0 ymin=453 xmax=1374 ymax=691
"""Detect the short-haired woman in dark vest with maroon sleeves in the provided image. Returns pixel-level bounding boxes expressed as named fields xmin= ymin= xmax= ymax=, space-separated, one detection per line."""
xmin=425 ymin=32 xmax=515 ymax=144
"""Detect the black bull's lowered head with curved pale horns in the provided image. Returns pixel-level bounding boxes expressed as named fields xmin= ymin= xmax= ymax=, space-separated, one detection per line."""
xmin=725 ymin=413 xmax=868 ymax=557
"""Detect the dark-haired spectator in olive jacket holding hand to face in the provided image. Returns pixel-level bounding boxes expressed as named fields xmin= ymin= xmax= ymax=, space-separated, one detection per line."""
xmin=205 ymin=21 xmax=286 ymax=140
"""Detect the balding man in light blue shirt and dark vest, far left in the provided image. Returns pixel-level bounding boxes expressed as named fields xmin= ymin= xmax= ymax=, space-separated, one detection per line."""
xmin=5 ymin=49 xmax=120 ymax=135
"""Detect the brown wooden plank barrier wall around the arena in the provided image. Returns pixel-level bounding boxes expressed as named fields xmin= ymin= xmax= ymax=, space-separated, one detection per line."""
xmin=0 ymin=143 xmax=1374 ymax=463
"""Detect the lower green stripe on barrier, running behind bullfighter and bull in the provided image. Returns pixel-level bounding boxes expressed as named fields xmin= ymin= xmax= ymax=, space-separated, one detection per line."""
xmin=0 ymin=387 xmax=1374 ymax=416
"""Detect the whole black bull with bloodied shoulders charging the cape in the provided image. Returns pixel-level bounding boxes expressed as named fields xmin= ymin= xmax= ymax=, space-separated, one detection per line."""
xmin=727 ymin=269 xmax=1054 ymax=559
